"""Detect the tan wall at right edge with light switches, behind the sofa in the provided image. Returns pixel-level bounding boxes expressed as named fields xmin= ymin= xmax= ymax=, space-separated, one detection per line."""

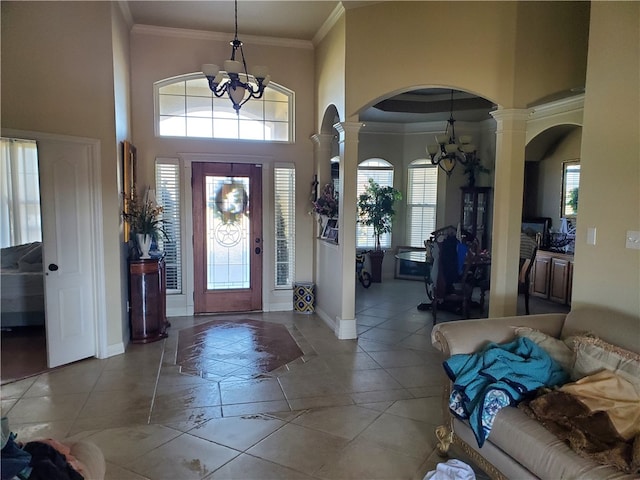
xmin=572 ymin=2 xmax=640 ymax=316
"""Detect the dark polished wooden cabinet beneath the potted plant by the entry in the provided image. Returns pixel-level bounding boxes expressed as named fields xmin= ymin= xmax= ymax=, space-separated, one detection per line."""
xmin=129 ymin=258 xmax=169 ymax=343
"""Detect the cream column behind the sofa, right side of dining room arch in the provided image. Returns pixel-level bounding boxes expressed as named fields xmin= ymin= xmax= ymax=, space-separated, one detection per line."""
xmin=489 ymin=109 xmax=530 ymax=317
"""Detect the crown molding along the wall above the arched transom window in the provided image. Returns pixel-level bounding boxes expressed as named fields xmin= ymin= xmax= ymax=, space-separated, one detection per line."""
xmin=131 ymin=23 xmax=313 ymax=50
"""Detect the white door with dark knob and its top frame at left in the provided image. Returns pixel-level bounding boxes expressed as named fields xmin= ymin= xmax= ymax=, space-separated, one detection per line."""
xmin=3 ymin=130 xmax=106 ymax=380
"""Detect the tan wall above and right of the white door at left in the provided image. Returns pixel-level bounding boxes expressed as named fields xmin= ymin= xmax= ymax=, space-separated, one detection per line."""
xmin=1 ymin=2 xmax=125 ymax=345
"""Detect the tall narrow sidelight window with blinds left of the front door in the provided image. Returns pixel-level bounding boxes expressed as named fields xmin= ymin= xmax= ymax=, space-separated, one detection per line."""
xmin=156 ymin=159 xmax=182 ymax=294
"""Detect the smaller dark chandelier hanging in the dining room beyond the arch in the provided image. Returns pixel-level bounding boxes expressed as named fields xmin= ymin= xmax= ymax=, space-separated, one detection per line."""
xmin=427 ymin=90 xmax=480 ymax=176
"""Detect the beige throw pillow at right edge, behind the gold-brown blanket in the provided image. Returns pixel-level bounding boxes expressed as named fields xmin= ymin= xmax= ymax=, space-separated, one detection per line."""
xmin=571 ymin=337 xmax=640 ymax=389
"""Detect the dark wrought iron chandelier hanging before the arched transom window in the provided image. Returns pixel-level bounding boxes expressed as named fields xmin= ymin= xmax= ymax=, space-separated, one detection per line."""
xmin=202 ymin=0 xmax=271 ymax=114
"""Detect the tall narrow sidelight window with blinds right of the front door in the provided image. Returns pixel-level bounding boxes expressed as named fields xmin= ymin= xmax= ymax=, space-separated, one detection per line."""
xmin=273 ymin=166 xmax=296 ymax=288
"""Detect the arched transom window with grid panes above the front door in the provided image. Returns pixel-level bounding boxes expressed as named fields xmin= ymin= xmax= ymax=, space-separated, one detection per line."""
xmin=154 ymin=73 xmax=294 ymax=143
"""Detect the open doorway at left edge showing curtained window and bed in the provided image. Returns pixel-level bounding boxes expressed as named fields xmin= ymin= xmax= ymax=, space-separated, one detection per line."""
xmin=0 ymin=137 xmax=47 ymax=384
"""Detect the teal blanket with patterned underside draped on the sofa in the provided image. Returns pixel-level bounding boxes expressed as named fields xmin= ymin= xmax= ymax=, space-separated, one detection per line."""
xmin=443 ymin=337 xmax=569 ymax=447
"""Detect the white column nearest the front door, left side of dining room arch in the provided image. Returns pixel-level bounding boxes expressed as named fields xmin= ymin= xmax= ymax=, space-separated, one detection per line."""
xmin=334 ymin=122 xmax=363 ymax=339
